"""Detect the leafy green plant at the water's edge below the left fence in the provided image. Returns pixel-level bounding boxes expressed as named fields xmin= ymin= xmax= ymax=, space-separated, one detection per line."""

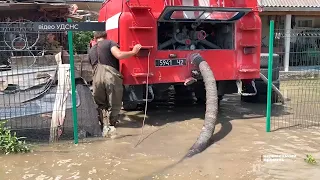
xmin=0 ymin=121 xmax=31 ymax=154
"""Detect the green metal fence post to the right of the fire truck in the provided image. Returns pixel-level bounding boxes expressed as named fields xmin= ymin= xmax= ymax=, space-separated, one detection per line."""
xmin=266 ymin=20 xmax=274 ymax=132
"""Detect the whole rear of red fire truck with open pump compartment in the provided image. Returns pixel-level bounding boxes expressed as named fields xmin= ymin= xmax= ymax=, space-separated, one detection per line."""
xmin=98 ymin=0 xmax=268 ymax=110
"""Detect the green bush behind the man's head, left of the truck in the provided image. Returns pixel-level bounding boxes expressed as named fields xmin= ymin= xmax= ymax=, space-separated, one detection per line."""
xmin=73 ymin=31 xmax=93 ymax=54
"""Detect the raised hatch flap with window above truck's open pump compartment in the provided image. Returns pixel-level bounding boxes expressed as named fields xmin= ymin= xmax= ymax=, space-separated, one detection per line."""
xmin=158 ymin=6 xmax=252 ymax=22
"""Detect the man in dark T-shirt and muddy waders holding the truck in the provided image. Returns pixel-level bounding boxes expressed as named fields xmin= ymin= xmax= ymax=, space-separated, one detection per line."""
xmin=89 ymin=31 xmax=141 ymax=137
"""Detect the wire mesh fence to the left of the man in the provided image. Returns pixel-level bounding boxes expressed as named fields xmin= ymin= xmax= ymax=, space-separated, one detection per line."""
xmin=0 ymin=20 xmax=101 ymax=142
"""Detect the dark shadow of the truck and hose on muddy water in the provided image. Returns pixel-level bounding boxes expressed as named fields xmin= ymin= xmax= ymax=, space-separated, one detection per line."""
xmin=119 ymin=95 xmax=288 ymax=150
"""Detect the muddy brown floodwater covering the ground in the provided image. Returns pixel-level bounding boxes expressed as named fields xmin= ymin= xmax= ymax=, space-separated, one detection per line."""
xmin=0 ymin=96 xmax=320 ymax=180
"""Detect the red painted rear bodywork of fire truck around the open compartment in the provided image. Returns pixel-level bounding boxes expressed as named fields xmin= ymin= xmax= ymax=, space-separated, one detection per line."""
xmin=99 ymin=0 xmax=261 ymax=85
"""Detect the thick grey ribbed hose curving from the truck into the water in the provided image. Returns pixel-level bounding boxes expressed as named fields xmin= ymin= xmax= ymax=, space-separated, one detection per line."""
xmin=185 ymin=53 xmax=218 ymax=157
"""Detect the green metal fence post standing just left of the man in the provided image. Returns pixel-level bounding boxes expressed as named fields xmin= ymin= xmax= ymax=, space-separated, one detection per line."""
xmin=68 ymin=18 xmax=79 ymax=144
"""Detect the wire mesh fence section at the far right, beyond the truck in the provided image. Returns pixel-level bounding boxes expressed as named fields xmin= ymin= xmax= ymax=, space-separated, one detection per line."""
xmin=271 ymin=28 xmax=320 ymax=130
